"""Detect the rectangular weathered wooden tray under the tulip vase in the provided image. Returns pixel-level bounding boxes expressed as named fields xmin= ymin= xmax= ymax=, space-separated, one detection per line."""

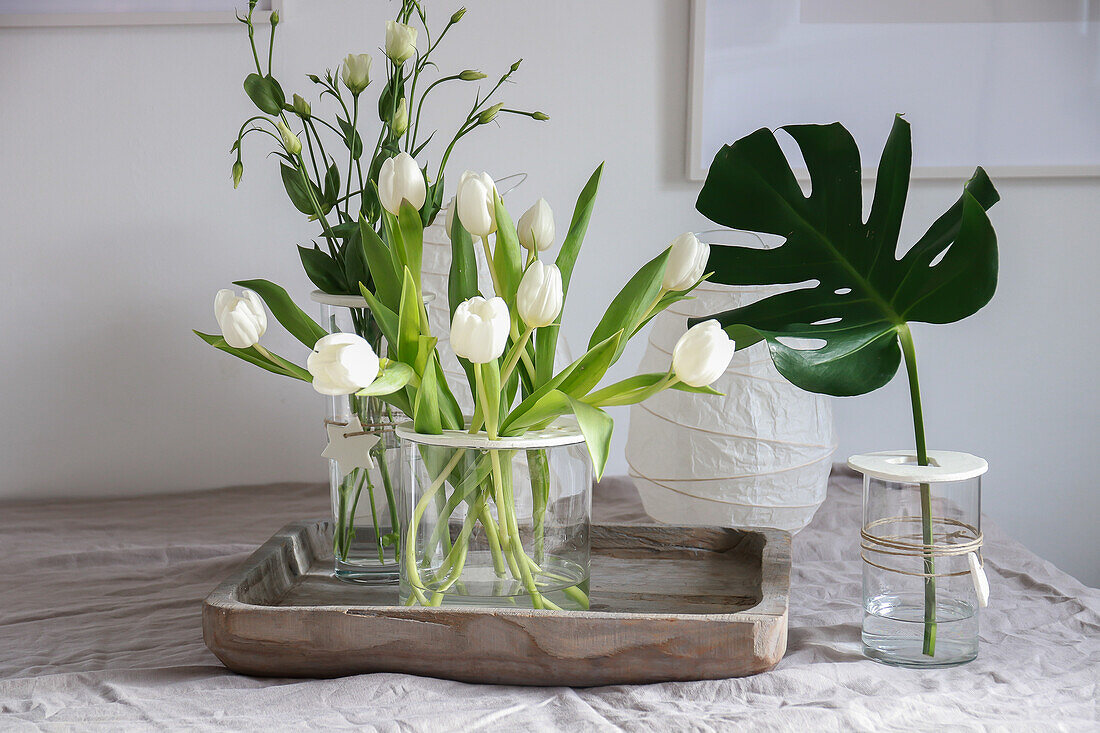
xmin=202 ymin=522 xmax=791 ymax=687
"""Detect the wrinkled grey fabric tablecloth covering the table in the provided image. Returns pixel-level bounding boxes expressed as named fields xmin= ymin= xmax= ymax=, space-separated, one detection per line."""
xmin=0 ymin=468 xmax=1100 ymax=731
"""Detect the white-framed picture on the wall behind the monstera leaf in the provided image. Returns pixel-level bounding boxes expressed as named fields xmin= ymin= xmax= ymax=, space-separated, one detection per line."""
xmin=686 ymin=0 xmax=1100 ymax=180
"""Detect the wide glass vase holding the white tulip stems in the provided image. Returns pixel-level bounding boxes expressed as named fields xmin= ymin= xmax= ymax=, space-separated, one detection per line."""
xmin=397 ymin=422 xmax=592 ymax=610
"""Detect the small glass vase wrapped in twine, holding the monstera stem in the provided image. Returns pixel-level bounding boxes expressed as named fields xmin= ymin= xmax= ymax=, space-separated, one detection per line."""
xmin=848 ymin=450 xmax=988 ymax=668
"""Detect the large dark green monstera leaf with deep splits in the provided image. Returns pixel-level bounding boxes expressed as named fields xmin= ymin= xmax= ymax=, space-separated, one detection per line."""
xmin=696 ymin=117 xmax=999 ymax=396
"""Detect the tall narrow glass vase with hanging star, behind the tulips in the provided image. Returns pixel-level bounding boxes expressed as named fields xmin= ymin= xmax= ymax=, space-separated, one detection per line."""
xmin=311 ymin=291 xmax=408 ymax=584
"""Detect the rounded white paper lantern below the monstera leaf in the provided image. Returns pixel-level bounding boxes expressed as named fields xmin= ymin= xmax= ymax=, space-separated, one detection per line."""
xmin=626 ymin=283 xmax=836 ymax=532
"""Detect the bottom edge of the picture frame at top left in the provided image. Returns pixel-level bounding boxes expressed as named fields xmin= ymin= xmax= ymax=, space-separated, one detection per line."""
xmin=0 ymin=0 xmax=283 ymax=29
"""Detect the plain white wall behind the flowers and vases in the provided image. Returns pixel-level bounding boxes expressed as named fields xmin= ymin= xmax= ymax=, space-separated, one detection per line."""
xmin=0 ymin=0 xmax=1100 ymax=584
